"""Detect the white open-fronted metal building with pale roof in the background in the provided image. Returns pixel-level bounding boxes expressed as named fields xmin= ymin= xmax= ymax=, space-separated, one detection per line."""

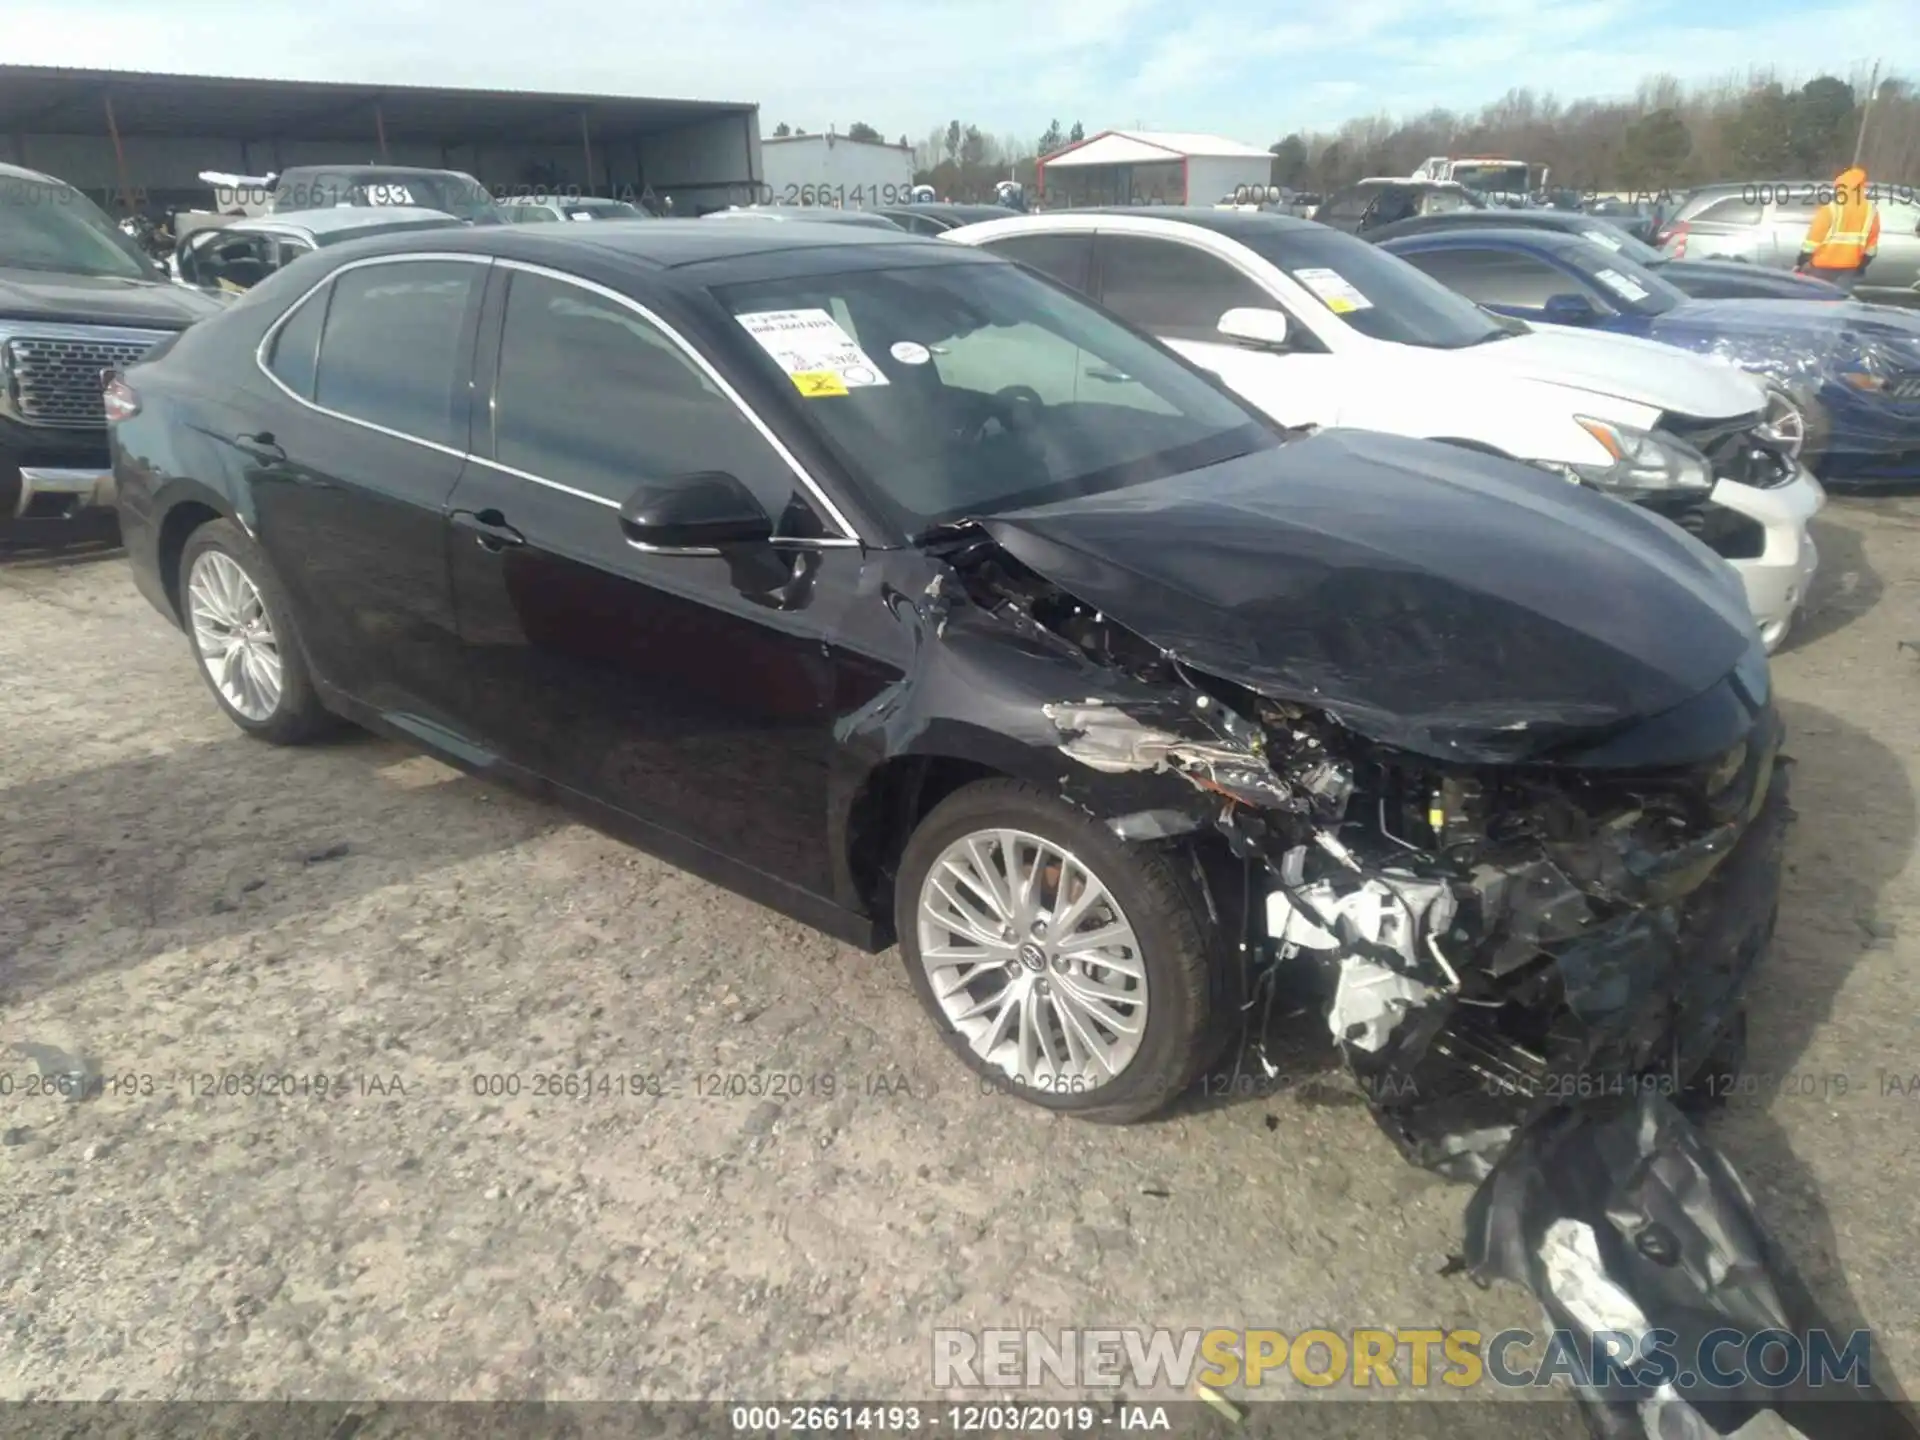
xmin=1036 ymin=131 xmax=1273 ymax=209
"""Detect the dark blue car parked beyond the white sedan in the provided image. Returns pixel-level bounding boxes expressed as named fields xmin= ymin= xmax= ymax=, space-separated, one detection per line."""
xmin=1380 ymin=228 xmax=1920 ymax=486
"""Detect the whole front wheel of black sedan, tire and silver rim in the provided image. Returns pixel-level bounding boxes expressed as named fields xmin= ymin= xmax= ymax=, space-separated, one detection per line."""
xmin=895 ymin=780 xmax=1219 ymax=1123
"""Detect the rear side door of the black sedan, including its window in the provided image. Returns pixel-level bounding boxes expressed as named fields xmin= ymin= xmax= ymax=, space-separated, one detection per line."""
xmin=253 ymin=255 xmax=488 ymax=747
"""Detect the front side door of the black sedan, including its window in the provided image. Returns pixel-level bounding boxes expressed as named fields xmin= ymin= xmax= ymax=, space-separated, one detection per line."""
xmin=449 ymin=261 xmax=860 ymax=895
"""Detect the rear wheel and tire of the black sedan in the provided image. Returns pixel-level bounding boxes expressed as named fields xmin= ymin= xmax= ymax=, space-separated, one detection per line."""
xmin=180 ymin=520 xmax=332 ymax=745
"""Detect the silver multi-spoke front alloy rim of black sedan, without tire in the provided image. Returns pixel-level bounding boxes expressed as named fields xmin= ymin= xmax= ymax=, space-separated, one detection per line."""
xmin=916 ymin=829 xmax=1148 ymax=1094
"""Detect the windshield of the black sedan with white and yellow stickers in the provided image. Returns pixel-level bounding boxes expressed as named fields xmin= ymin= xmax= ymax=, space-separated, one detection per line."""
xmin=714 ymin=261 xmax=1279 ymax=536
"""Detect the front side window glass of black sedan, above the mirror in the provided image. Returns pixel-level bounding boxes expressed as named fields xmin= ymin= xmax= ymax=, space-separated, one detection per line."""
xmin=493 ymin=271 xmax=818 ymax=534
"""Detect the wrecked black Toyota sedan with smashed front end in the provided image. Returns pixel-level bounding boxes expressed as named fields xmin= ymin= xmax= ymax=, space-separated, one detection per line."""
xmin=106 ymin=221 xmax=1784 ymax=1164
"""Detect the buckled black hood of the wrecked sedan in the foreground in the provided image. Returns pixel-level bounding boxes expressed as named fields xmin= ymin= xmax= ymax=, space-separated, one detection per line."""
xmin=979 ymin=430 xmax=1755 ymax=764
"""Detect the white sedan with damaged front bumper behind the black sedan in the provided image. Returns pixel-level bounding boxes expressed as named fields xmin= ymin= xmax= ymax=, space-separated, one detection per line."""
xmin=943 ymin=207 xmax=1826 ymax=649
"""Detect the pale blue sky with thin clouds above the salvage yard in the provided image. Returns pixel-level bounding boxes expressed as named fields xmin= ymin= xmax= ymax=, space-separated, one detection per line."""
xmin=6 ymin=0 xmax=1920 ymax=144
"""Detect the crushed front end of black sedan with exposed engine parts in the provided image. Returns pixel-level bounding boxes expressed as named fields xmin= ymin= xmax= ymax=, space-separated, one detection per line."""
xmin=936 ymin=518 xmax=1789 ymax=1179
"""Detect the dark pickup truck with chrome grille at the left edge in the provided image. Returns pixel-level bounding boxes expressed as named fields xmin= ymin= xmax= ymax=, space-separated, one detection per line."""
xmin=0 ymin=165 xmax=221 ymax=538
